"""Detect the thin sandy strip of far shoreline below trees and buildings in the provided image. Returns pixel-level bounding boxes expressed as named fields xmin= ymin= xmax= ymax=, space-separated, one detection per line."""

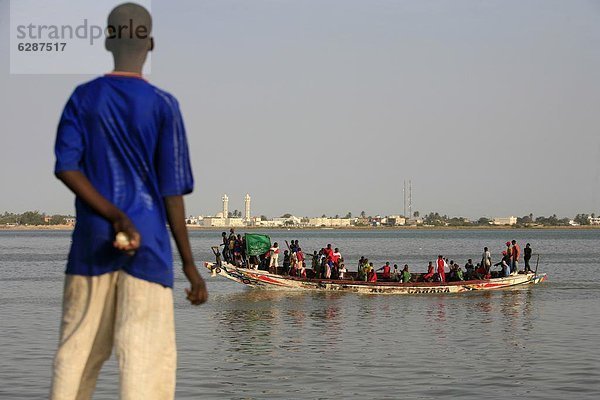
xmin=0 ymin=225 xmax=600 ymax=231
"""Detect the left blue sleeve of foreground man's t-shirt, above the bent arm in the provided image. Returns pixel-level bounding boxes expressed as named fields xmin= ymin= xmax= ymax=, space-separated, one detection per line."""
xmin=54 ymin=93 xmax=84 ymax=173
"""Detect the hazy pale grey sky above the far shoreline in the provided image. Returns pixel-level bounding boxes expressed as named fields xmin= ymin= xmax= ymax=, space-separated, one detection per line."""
xmin=0 ymin=0 xmax=600 ymax=217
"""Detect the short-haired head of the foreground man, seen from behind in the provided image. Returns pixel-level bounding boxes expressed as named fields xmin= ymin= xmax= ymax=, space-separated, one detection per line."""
xmin=106 ymin=3 xmax=154 ymax=59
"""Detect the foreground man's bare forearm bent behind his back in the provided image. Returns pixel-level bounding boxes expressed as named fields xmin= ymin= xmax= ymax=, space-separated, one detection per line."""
xmin=56 ymin=171 xmax=141 ymax=251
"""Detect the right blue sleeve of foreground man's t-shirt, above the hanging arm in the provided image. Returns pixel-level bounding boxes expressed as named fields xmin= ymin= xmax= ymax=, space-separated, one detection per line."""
xmin=155 ymin=95 xmax=194 ymax=196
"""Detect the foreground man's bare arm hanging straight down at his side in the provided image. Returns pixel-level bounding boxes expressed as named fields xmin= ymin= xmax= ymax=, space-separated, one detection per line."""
xmin=165 ymin=196 xmax=208 ymax=305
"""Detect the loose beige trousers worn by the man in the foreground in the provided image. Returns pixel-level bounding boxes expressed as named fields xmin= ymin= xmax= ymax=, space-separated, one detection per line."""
xmin=51 ymin=271 xmax=177 ymax=400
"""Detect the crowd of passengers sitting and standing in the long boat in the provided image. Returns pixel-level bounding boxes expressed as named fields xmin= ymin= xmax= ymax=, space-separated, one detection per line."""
xmin=222 ymin=229 xmax=532 ymax=283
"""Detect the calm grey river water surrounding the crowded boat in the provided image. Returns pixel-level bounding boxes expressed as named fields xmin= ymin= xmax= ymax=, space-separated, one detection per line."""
xmin=0 ymin=230 xmax=600 ymax=399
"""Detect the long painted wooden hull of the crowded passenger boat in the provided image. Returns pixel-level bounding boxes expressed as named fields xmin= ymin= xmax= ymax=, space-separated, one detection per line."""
xmin=204 ymin=262 xmax=546 ymax=294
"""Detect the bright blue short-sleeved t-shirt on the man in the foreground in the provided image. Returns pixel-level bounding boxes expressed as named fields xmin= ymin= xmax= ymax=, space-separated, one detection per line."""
xmin=55 ymin=75 xmax=194 ymax=287
